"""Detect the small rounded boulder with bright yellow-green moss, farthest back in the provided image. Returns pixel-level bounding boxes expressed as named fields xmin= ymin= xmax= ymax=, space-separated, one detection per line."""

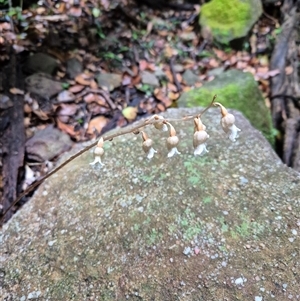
xmin=200 ymin=0 xmax=262 ymax=44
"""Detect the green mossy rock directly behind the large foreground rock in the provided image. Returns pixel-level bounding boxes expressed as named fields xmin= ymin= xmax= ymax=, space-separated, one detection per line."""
xmin=178 ymin=70 xmax=275 ymax=145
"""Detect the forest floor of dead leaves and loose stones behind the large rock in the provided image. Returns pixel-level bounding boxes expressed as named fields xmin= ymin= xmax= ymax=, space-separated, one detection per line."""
xmin=0 ymin=0 xmax=300 ymax=221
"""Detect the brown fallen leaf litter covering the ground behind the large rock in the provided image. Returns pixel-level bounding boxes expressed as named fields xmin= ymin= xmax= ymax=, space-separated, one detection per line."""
xmin=0 ymin=0 xmax=290 ymax=217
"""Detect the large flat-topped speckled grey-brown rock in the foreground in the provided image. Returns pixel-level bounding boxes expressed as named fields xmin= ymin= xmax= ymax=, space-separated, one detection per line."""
xmin=0 ymin=109 xmax=300 ymax=301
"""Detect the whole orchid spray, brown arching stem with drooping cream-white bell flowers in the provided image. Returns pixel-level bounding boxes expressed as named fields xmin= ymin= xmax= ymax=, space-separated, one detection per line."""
xmin=0 ymin=95 xmax=240 ymax=225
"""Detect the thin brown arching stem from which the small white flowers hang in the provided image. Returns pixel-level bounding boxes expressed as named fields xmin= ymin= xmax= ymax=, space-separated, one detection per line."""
xmin=0 ymin=95 xmax=217 ymax=225
